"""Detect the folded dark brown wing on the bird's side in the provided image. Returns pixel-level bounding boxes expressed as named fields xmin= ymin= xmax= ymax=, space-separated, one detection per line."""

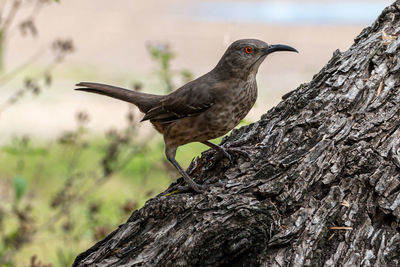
xmin=142 ymin=79 xmax=214 ymax=123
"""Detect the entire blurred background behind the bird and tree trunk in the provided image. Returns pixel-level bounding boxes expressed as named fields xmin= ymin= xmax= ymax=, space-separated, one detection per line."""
xmin=0 ymin=0 xmax=392 ymax=266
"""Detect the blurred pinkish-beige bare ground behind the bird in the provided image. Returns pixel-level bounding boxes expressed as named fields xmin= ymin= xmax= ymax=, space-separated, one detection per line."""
xmin=0 ymin=0 xmax=394 ymax=142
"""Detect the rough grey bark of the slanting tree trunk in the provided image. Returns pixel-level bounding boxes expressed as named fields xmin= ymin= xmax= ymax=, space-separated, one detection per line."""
xmin=74 ymin=0 xmax=400 ymax=266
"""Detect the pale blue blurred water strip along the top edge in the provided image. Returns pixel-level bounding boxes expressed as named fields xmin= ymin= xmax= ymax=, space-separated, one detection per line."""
xmin=189 ymin=0 xmax=392 ymax=25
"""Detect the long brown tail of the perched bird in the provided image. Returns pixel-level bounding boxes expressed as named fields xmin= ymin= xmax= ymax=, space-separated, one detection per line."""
xmin=75 ymin=82 xmax=164 ymax=113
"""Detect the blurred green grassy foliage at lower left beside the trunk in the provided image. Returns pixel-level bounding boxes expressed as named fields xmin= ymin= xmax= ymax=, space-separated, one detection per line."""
xmin=0 ymin=136 xmax=176 ymax=266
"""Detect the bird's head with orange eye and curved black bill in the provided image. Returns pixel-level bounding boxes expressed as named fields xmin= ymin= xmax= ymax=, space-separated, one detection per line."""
xmin=217 ymin=39 xmax=297 ymax=77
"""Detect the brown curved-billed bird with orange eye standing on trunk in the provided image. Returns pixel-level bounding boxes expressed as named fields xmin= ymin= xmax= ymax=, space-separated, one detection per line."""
xmin=75 ymin=39 xmax=298 ymax=193
